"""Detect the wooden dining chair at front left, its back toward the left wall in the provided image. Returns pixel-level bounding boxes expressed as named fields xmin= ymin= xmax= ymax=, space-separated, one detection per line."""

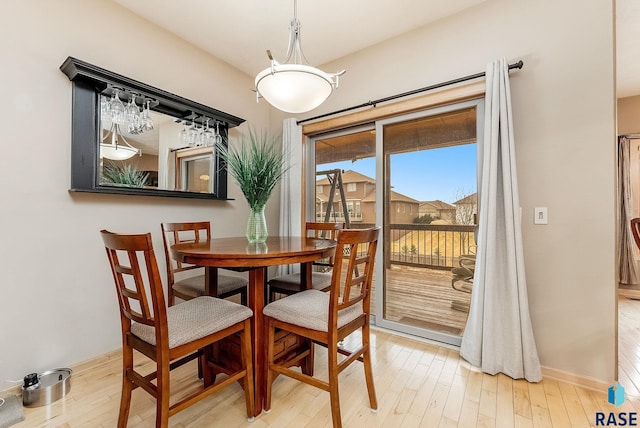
xmin=100 ymin=230 xmax=254 ymax=427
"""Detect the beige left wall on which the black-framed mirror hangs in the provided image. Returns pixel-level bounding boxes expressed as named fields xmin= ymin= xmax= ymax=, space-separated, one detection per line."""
xmin=0 ymin=0 xmax=278 ymax=390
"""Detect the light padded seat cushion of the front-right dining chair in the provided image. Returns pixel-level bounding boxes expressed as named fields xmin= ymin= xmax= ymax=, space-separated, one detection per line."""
xmin=262 ymin=290 xmax=363 ymax=332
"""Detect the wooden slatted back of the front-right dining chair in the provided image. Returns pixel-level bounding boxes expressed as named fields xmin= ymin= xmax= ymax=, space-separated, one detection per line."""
xmin=329 ymin=227 xmax=380 ymax=331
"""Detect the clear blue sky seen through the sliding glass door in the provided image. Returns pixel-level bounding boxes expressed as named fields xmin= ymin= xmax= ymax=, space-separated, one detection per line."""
xmin=318 ymin=144 xmax=477 ymax=203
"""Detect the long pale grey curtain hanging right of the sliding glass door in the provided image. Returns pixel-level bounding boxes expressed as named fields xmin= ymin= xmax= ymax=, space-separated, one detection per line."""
xmin=460 ymin=59 xmax=542 ymax=382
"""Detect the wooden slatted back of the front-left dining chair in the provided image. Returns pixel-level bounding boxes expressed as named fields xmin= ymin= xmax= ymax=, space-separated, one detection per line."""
xmin=100 ymin=230 xmax=168 ymax=334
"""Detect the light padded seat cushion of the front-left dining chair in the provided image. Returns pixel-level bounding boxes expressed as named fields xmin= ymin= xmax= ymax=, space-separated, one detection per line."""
xmin=131 ymin=296 xmax=253 ymax=349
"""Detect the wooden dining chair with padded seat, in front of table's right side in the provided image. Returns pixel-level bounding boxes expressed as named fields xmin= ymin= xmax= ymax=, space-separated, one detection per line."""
xmin=262 ymin=228 xmax=380 ymax=427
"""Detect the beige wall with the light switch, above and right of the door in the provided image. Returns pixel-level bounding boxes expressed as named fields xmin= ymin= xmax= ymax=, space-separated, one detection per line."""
xmin=290 ymin=0 xmax=616 ymax=383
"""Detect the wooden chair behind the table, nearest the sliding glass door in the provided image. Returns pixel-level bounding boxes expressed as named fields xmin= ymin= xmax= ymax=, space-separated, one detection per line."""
xmin=267 ymin=222 xmax=344 ymax=302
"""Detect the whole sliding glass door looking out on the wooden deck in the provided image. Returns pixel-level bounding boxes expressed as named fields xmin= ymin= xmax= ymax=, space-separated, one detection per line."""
xmin=307 ymin=101 xmax=482 ymax=345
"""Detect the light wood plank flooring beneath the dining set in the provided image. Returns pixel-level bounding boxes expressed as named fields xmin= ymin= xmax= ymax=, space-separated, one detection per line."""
xmin=8 ymin=298 xmax=640 ymax=428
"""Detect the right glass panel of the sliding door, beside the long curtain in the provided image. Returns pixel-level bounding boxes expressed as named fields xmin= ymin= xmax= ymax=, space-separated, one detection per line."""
xmin=376 ymin=103 xmax=478 ymax=345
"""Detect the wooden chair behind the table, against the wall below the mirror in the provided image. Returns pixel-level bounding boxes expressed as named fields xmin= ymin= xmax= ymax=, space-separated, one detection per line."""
xmin=160 ymin=221 xmax=248 ymax=306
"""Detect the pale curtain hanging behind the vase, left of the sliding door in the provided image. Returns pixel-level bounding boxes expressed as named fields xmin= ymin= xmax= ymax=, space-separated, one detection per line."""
xmin=279 ymin=118 xmax=302 ymax=275
